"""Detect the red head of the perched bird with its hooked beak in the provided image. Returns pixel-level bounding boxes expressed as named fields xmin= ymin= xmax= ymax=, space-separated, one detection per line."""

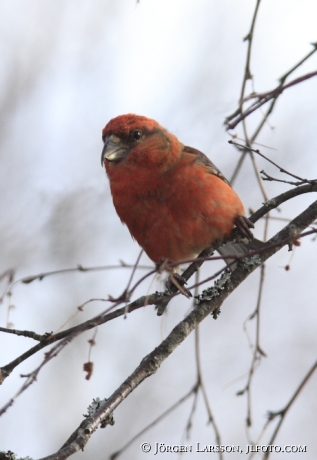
xmin=101 ymin=114 xmax=182 ymax=174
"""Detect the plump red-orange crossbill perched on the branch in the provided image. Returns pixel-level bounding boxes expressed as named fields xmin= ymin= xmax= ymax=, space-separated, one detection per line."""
xmin=101 ymin=114 xmax=253 ymax=263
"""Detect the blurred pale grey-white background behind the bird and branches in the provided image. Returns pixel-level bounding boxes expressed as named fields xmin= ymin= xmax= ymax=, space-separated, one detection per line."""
xmin=0 ymin=0 xmax=317 ymax=460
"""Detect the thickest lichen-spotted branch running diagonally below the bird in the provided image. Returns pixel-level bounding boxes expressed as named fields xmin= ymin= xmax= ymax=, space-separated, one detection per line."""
xmin=37 ymin=201 xmax=317 ymax=460
